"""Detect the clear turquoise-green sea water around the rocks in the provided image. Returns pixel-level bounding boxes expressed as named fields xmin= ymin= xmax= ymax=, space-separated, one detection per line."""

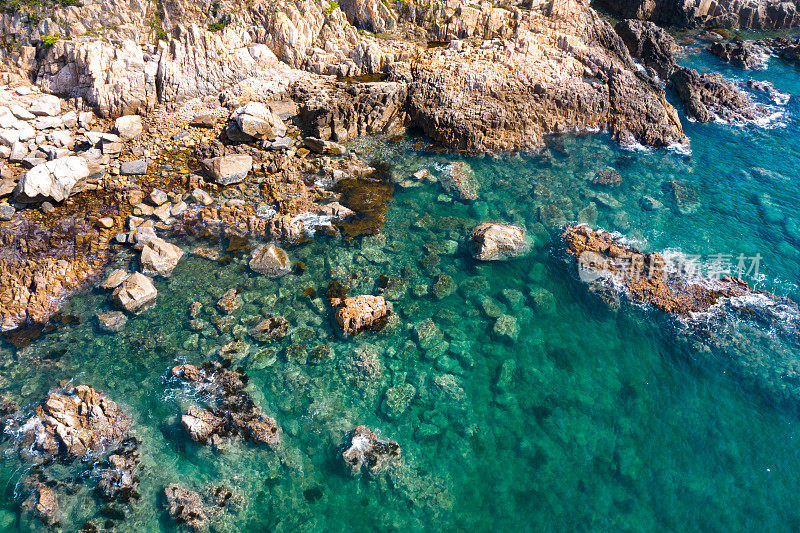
xmin=0 ymin=54 xmax=800 ymax=531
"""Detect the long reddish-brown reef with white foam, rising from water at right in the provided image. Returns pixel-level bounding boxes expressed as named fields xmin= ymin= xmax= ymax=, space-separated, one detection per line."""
xmin=563 ymin=226 xmax=753 ymax=318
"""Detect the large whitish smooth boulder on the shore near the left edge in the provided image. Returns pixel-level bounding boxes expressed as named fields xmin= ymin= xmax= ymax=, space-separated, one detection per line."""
xmin=14 ymin=156 xmax=90 ymax=202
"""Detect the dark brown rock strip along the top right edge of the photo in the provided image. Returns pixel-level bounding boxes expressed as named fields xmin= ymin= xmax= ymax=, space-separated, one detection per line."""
xmin=602 ymin=0 xmax=800 ymax=29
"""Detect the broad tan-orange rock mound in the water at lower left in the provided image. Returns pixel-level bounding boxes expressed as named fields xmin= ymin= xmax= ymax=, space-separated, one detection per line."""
xmin=22 ymin=385 xmax=131 ymax=459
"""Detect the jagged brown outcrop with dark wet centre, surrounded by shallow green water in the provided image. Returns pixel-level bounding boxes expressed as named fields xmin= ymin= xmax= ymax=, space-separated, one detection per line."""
xmin=172 ymin=362 xmax=280 ymax=446
